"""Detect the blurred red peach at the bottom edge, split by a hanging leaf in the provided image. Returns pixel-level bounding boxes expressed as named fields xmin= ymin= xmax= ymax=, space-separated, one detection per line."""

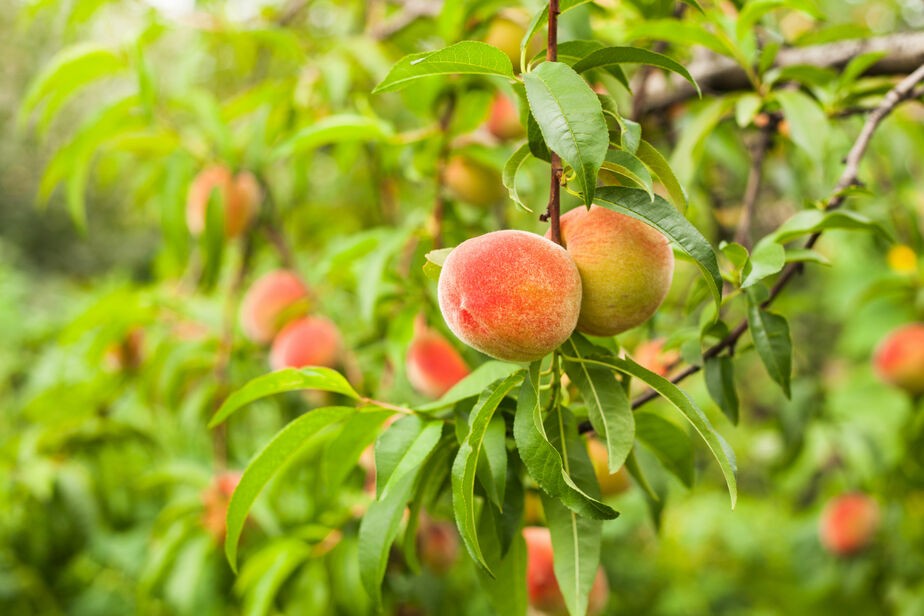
xmin=523 ymin=526 xmax=610 ymax=615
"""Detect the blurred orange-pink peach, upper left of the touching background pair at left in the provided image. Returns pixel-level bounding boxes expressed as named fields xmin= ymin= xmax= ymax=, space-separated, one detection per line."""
xmin=240 ymin=270 xmax=308 ymax=343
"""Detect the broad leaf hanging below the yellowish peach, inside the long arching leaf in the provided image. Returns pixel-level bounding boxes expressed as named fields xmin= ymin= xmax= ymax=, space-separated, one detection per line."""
xmin=564 ymin=333 xmax=635 ymax=473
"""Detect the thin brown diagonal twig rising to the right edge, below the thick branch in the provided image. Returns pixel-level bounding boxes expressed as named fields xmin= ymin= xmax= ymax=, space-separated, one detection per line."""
xmin=580 ymin=64 xmax=924 ymax=432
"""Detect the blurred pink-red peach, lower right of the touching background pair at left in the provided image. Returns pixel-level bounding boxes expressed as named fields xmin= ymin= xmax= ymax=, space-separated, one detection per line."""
xmin=270 ymin=317 xmax=341 ymax=370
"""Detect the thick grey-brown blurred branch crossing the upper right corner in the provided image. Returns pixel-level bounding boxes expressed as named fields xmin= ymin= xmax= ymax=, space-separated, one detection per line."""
xmin=639 ymin=32 xmax=924 ymax=113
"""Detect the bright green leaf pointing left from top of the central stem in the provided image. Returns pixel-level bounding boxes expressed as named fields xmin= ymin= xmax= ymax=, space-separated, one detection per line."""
xmin=372 ymin=41 xmax=514 ymax=94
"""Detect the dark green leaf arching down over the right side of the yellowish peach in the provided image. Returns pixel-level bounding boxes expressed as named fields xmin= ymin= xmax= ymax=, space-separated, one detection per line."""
xmin=596 ymin=186 xmax=722 ymax=316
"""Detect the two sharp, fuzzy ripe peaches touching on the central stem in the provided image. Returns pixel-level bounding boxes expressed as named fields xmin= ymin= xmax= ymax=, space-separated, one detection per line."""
xmin=438 ymin=212 xmax=674 ymax=362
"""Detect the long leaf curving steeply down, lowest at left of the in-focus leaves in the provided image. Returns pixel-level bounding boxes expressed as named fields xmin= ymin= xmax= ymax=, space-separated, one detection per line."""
xmin=225 ymin=406 xmax=357 ymax=571
